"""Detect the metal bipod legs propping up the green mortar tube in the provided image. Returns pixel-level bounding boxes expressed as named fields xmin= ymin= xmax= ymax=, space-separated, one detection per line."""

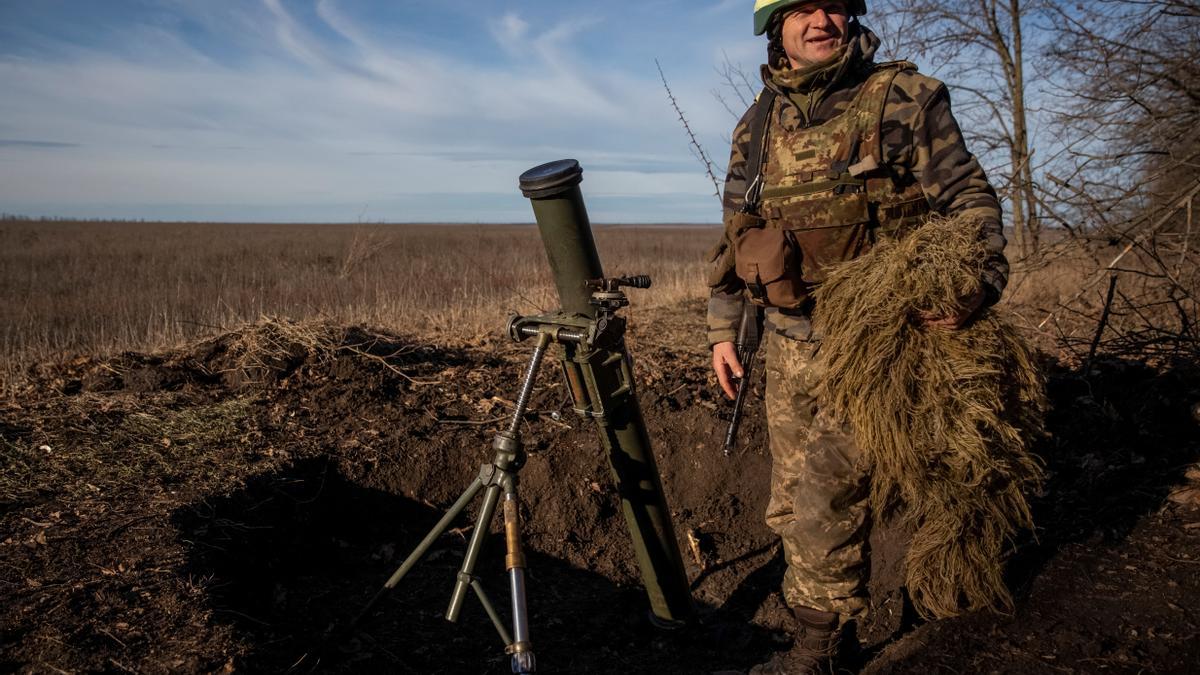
xmin=350 ymin=331 xmax=551 ymax=675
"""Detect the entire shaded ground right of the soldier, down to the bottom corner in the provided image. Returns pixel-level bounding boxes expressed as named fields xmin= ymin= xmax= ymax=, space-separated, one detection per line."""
xmin=866 ymin=360 xmax=1200 ymax=674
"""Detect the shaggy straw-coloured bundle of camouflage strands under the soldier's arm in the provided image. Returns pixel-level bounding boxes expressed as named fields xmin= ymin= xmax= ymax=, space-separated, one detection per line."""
xmin=814 ymin=212 xmax=1045 ymax=617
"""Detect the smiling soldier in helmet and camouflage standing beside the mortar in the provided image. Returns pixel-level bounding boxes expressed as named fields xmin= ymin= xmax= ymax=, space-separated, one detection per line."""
xmin=708 ymin=0 xmax=1008 ymax=673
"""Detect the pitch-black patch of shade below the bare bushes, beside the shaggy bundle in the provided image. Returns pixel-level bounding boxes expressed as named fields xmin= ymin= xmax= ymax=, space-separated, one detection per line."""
xmin=1009 ymin=359 xmax=1200 ymax=595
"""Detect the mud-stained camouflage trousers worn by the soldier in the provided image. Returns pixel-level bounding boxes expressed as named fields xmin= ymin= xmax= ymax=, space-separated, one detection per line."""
xmin=767 ymin=334 xmax=870 ymax=620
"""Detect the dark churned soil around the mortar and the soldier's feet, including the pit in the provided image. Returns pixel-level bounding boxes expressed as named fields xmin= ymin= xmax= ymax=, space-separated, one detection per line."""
xmin=0 ymin=306 xmax=1200 ymax=673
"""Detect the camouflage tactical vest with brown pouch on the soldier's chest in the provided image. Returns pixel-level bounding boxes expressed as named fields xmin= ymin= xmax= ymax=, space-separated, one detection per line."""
xmin=731 ymin=61 xmax=930 ymax=309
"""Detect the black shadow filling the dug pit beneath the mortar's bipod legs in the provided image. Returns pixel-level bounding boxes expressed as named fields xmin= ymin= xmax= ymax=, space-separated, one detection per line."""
xmin=174 ymin=458 xmax=772 ymax=673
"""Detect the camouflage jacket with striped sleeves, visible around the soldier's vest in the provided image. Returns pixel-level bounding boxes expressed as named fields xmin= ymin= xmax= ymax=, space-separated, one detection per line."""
xmin=708 ymin=29 xmax=1008 ymax=345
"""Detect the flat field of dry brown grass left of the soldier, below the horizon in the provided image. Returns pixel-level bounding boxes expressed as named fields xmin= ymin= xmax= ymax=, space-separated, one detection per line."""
xmin=0 ymin=221 xmax=718 ymax=382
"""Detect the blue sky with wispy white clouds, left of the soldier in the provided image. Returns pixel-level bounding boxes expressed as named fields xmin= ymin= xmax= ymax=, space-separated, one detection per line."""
xmin=0 ymin=0 xmax=763 ymax=222
